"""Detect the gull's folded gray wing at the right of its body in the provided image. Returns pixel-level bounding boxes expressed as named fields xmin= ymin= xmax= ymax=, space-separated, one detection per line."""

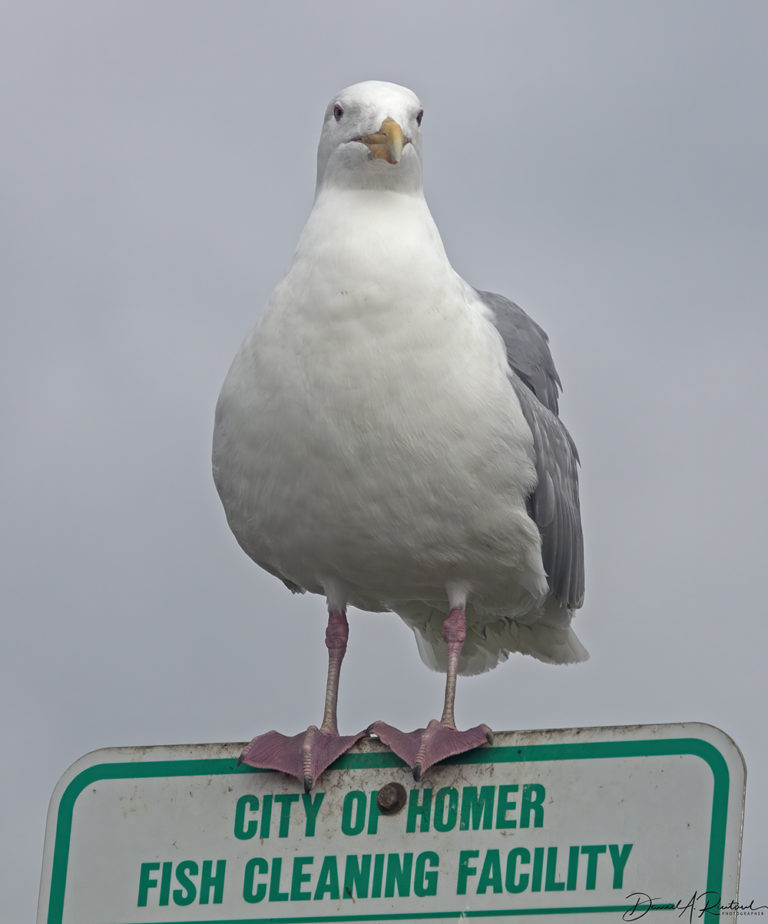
xmin=478 ymin=292 xmax=584 ymax=609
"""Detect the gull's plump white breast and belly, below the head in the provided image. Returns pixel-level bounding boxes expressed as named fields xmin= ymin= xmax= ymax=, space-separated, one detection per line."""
xmin=214 ymin=191 xmax=547 ymax=612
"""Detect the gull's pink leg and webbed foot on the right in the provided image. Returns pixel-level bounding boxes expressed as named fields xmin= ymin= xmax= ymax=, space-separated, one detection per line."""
xmin=369 ymin=605 xmax=493 ymax=780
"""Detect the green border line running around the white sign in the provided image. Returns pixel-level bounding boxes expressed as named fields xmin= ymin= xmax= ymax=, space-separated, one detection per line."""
xmin=48 ymin=738 xmax=730 ymax=924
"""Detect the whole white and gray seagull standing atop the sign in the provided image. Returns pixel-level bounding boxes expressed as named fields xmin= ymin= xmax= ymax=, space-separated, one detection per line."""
xmin=213 ymin=81 xmax=588 ymax=791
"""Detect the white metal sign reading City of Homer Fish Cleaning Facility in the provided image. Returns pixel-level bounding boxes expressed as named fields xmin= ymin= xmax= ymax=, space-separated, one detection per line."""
xmin=37 ymin=724 xmax=745 ymax=924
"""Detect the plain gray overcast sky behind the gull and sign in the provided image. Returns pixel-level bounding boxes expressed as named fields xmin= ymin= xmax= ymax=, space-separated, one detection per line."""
xmin=0 ymin=0 xmax=768 ymax=921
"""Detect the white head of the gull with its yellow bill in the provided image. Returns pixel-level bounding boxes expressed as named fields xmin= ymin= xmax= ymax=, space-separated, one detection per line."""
xmin=317 ymin=80 xmax=424 ymax=193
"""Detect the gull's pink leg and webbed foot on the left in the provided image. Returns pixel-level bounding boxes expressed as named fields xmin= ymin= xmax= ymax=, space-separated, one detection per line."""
xmin=240 ymin=610 xmax=365 ymax=792
